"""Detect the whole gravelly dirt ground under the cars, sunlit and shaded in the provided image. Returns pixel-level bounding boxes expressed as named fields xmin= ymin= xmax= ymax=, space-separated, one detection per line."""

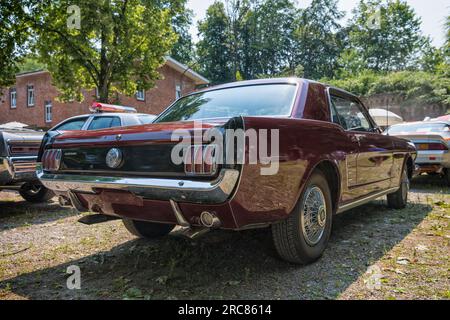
xmin=0 ymin=177 xmax=450 ymax=299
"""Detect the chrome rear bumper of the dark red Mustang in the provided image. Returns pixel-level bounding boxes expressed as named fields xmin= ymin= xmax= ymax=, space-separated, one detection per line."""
xmin=37 ymin=164 xmax=239 ymax=204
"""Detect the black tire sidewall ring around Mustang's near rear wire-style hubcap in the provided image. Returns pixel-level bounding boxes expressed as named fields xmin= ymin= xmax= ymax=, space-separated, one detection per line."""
xmin=294 ymin=172 xmax=333 ymax=262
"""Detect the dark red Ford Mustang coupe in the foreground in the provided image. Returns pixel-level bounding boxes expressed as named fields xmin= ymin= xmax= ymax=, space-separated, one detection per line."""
xmin=38 ymin=79 xmax=416 ymax=264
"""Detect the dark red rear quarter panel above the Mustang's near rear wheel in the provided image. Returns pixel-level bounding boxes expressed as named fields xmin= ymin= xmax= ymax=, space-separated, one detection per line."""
xmin=231 ymin=118 xmax=355 ymax=226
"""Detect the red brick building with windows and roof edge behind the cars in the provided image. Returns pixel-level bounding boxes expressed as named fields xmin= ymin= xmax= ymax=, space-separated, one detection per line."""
xmin=0 ymin=57 xmax=209 ymax=128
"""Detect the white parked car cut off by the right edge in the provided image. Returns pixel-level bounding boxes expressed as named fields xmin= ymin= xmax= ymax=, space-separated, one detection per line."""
xmin=387 ymin=120 xmax=450 ymax=185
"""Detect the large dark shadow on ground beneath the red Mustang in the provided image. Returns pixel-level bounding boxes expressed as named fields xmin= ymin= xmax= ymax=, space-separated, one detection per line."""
xmin=0 ymin=201 xmax=432 ymax=299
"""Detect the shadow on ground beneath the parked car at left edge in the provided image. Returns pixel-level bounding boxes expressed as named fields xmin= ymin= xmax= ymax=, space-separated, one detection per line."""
xmin=0 ymin=201 xmax=76 ymax=232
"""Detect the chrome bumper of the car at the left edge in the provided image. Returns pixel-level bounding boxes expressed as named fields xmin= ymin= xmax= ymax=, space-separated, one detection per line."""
xmin=0 ymin=157 xmax=37 ymax=184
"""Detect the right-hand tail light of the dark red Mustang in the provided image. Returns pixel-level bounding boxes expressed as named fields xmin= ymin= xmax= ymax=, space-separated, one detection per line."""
xmin=184 ymin=145 xmax=217 ymax=176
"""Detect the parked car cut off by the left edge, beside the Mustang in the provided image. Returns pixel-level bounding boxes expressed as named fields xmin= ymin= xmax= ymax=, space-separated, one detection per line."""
xmin=0 ymin=126 xmax=54 ymax=203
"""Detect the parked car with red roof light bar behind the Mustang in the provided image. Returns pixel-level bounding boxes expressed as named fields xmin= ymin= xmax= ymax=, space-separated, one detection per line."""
xmin=49 ymin=103 xmax=156 ymax=131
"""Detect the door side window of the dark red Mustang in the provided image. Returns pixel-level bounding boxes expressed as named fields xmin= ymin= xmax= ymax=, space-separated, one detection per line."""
xmin=331 ymin=96 xmax=373 ymax=132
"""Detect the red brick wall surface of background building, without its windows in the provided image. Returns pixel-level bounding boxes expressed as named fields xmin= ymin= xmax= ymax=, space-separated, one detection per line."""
xmin=0 ymin=65 xmax=196 ymax=128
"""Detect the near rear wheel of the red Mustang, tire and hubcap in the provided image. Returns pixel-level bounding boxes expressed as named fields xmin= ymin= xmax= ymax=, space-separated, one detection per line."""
xmin=272 ymin=171 xmax=333 ymax=265
